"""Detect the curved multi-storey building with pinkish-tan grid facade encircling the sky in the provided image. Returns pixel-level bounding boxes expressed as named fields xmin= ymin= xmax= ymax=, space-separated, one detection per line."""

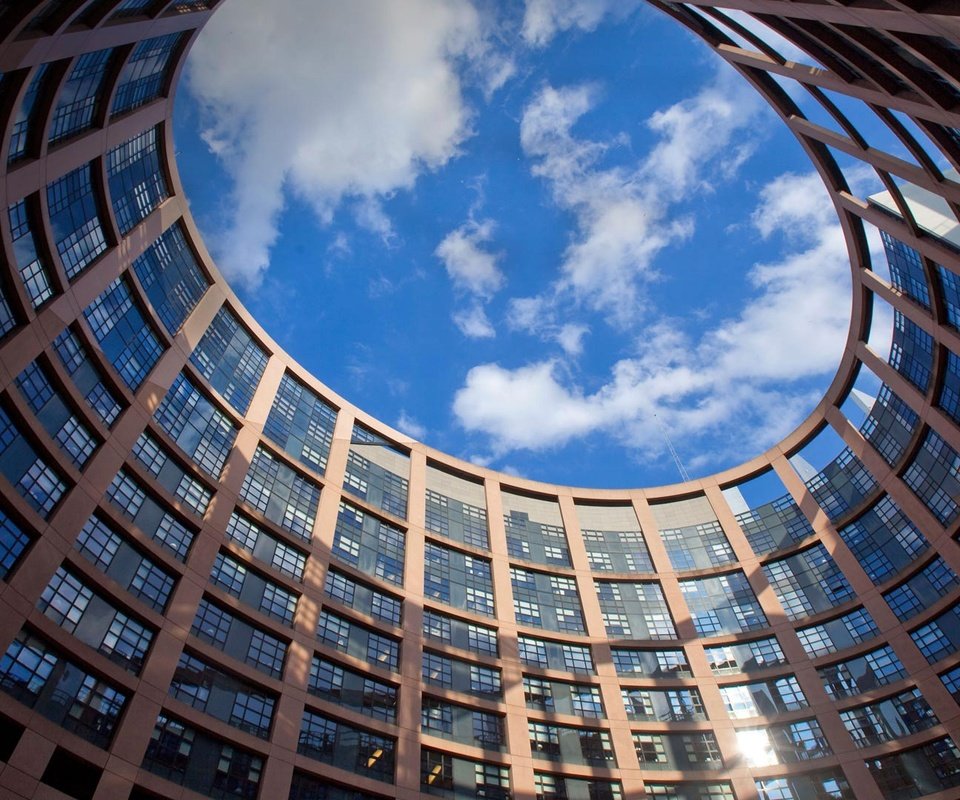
xmin=0 ymin=0 xmax=960 ymax=800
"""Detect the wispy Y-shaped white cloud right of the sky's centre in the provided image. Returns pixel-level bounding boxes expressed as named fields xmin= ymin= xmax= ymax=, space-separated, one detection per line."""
xmin=511 ymin=65 xmax=759 ymax=328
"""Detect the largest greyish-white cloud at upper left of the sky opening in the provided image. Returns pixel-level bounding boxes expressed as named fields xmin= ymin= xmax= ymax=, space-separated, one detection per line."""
xmin=187 ymin=0 xmax=511 ymax=287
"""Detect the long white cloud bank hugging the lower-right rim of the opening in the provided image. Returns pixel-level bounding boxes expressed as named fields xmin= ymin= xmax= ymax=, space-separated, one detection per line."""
xmin=453 ymin=169 xmax=850 ymax=468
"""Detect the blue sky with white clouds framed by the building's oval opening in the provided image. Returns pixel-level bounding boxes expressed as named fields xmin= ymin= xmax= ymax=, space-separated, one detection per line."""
xmin=176 ymin=0 xmax=864 ymax=486
